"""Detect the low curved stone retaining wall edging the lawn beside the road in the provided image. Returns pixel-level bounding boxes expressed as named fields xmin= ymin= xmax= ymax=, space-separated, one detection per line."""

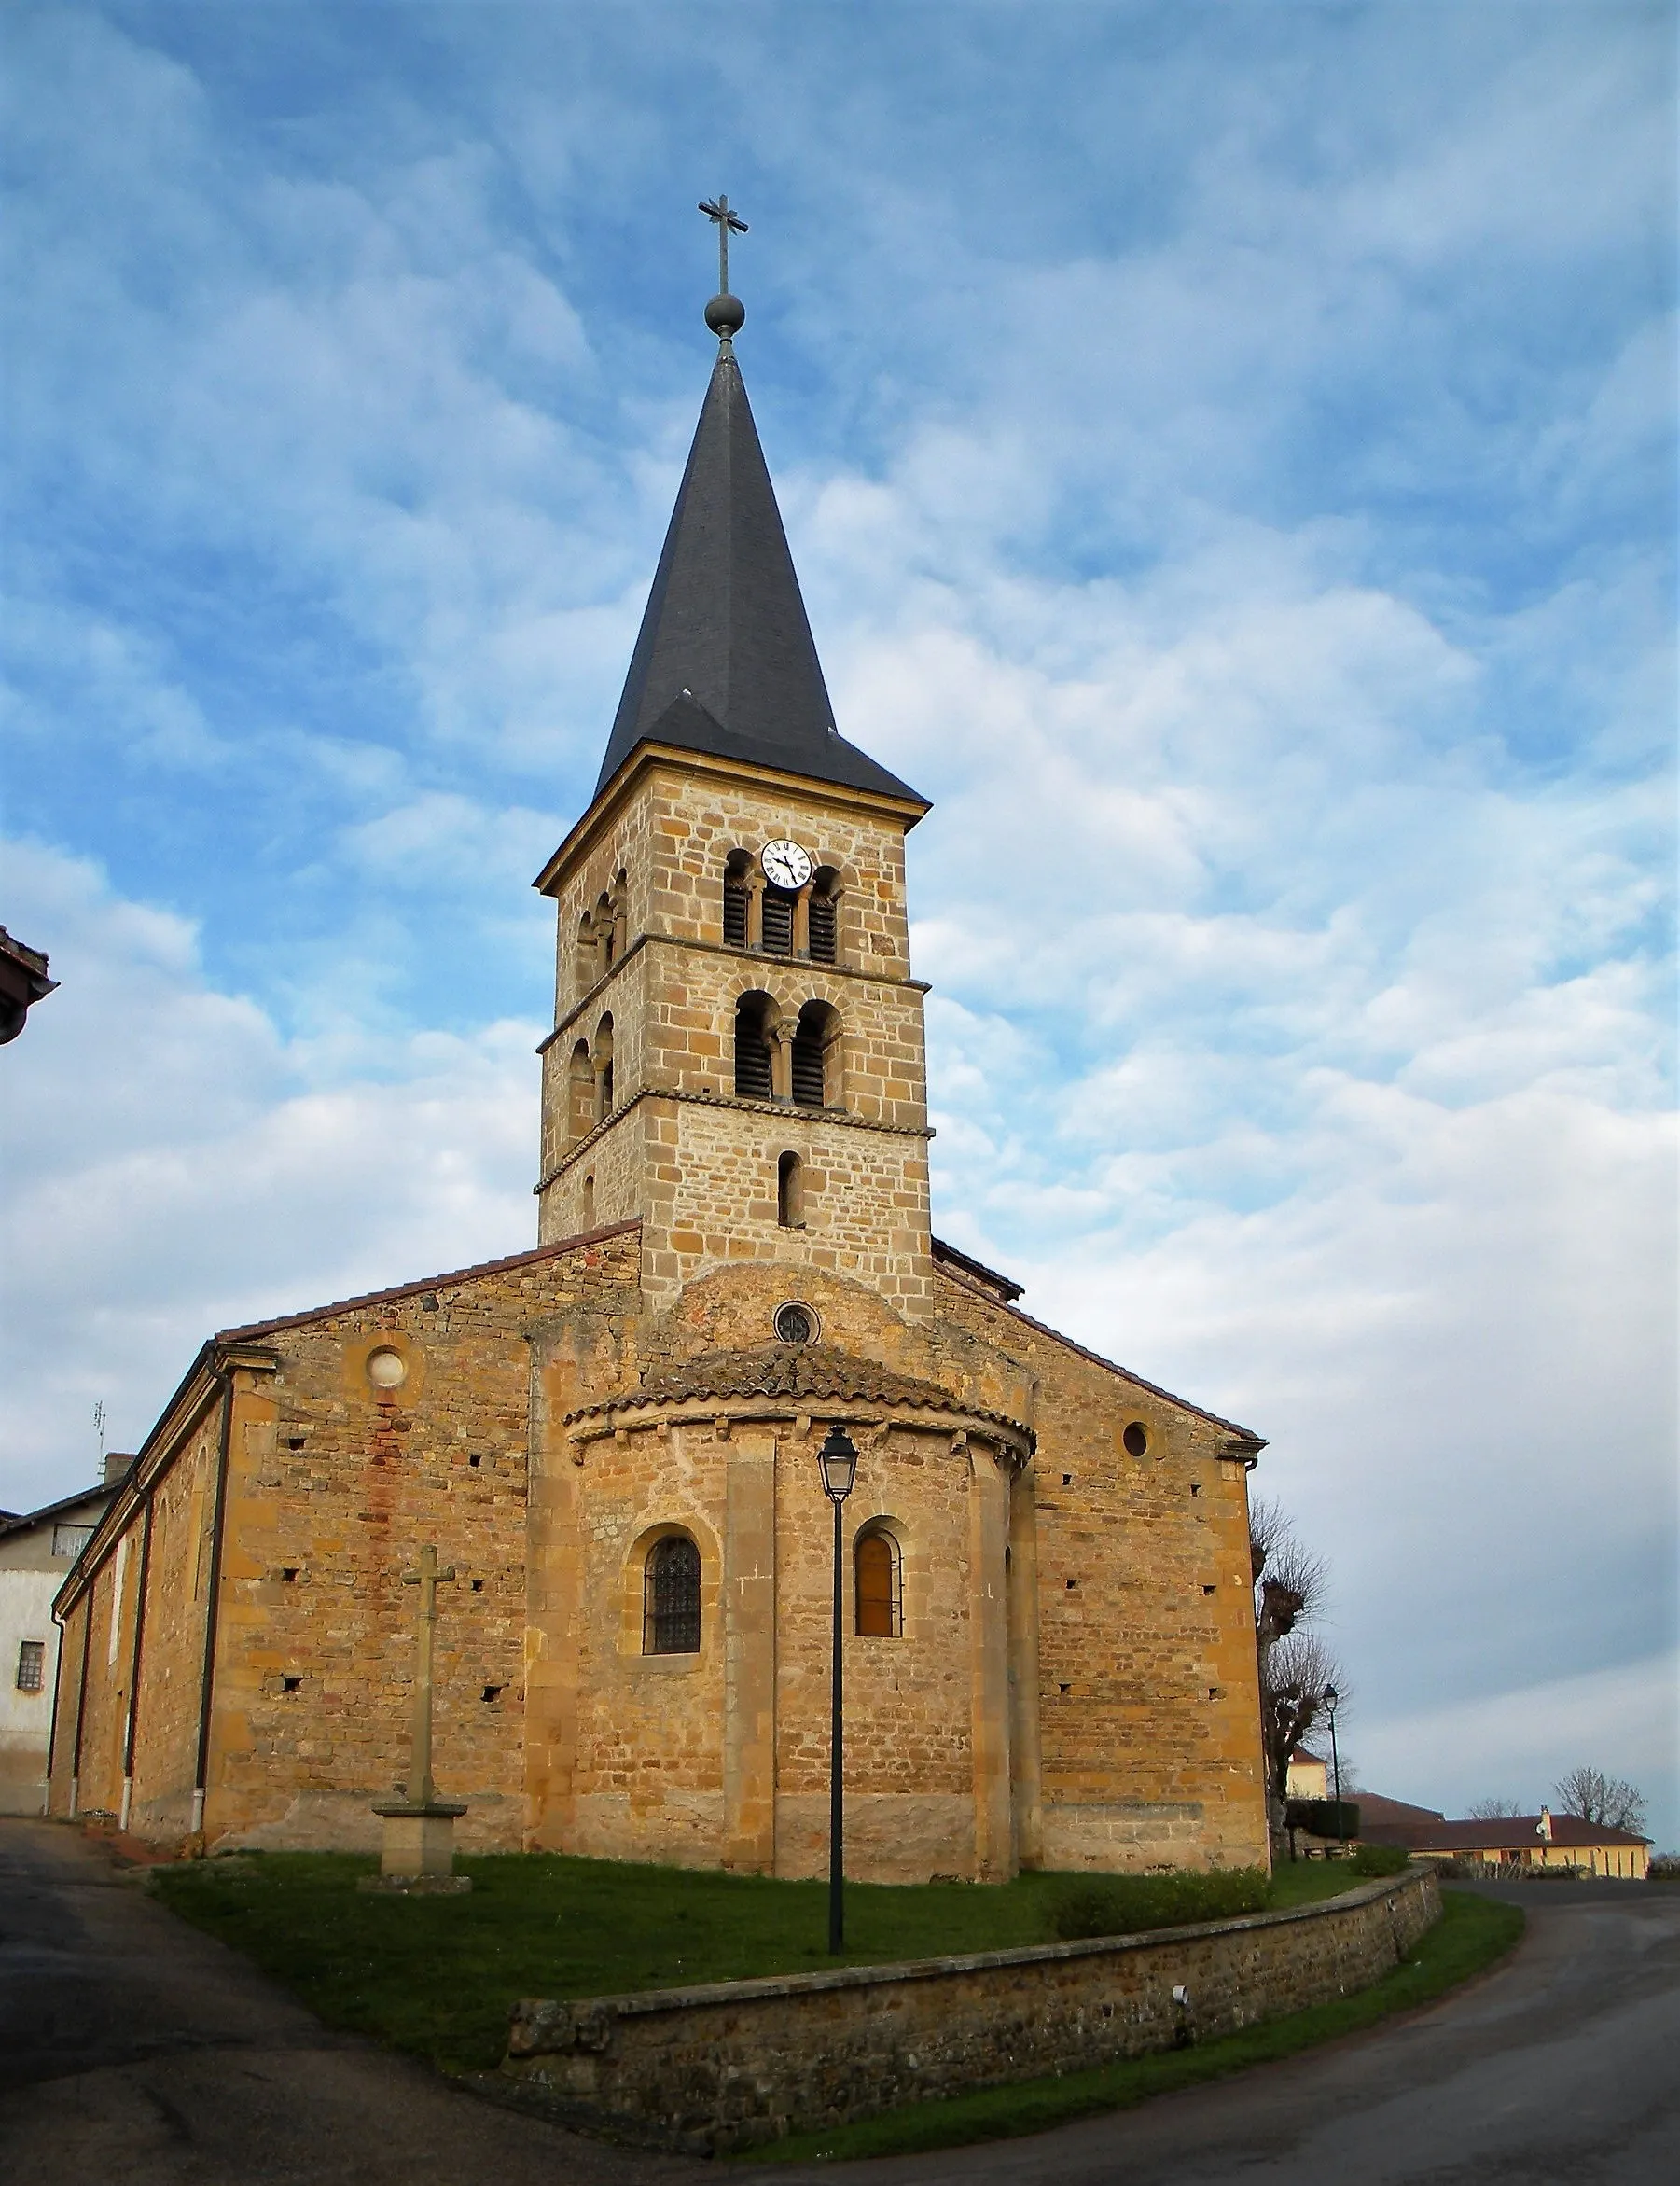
xmin=503 ymin=1867 xmax=1439 ymax=2153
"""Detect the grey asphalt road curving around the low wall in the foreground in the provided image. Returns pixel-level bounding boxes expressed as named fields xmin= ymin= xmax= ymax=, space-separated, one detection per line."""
xmin=0 ymin=1821 xmax=1680 ymax=2186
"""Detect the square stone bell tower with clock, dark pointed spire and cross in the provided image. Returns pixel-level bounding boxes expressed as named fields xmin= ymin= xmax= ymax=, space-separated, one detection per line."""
xmin=535 ymin=256 xmax=933 ymax=1320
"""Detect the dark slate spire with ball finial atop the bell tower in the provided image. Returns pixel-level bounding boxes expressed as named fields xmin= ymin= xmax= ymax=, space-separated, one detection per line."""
xmin=596 ymin=295 xmax=926 ymax=804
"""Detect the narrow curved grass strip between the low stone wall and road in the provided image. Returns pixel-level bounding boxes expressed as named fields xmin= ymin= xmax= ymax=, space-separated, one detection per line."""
xmin=745 ymin=1897 xmax=1522 ymax=2165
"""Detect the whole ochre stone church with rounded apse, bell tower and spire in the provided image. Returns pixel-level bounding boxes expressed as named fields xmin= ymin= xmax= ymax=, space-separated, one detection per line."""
xmin=50 ymin=282 xmax=1267 ymax=1880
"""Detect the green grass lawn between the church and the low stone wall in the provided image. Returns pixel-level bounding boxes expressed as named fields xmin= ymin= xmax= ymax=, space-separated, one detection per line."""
xmin=151 ymin=1852 xmax=1441 ymax=2072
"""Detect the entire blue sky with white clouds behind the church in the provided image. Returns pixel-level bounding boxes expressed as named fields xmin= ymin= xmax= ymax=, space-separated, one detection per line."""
xmin=0 ymin=0 xmax=1680 ymax=1843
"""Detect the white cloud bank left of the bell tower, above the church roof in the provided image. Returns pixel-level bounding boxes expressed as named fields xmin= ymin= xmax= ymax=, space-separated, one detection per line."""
xmin=0 ymin=843 xmax=539 ymax=1509
